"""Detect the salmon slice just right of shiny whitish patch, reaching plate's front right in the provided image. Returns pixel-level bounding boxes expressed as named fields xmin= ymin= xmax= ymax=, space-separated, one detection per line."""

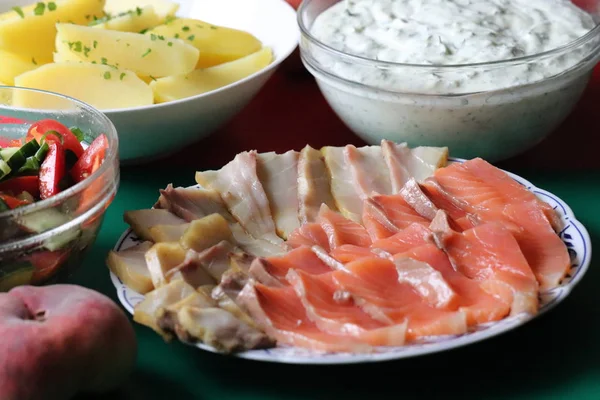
xmin=394 ymin=244 xmax=510 ymax=326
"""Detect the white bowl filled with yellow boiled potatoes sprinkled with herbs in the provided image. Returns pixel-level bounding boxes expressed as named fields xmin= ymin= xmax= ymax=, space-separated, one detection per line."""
xmin=0 ymin=0 xmax=300 ymax=163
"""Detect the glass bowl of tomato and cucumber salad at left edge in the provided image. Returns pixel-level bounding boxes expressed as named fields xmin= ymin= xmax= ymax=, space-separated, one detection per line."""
xmin=0 ymin=86 xmax=119 ymax=292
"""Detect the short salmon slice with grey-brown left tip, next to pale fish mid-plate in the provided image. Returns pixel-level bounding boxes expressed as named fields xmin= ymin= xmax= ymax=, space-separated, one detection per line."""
xmin=248 ymin=246 xmax=332 ymax=286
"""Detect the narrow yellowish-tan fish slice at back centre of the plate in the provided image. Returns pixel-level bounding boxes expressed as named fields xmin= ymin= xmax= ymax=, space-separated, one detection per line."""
xmin=298 ymin=146 xmax=337 ymax=224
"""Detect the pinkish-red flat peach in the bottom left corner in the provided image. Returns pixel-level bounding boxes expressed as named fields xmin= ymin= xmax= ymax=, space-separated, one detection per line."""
xmin=0 ymin=285 xmax=137 ymax=400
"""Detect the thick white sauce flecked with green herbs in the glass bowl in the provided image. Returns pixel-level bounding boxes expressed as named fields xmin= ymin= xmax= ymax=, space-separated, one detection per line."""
xmin=311 ymin=0 xmax=595 ymax=94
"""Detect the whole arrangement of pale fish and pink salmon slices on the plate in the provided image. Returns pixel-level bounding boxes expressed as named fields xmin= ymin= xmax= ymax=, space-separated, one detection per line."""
xmin=108 ymin=141 xmax=570 ymax=353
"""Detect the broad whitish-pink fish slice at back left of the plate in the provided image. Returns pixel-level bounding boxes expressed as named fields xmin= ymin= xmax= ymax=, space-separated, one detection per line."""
xmin=196 ymin=151 xmax=283 ymax=244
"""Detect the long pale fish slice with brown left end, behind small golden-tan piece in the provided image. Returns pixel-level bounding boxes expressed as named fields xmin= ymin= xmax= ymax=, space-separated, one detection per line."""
xmin=158 ymin=184 xmax=285 ymax=257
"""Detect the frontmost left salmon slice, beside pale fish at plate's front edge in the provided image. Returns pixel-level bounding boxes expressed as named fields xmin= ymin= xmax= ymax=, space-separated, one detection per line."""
xmin=238 ymin=282 xmax=372 ymax=353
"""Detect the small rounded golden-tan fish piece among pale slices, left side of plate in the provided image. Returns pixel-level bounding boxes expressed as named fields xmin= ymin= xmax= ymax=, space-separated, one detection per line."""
xmin=179 ymin=214 xmax=231 ymax=252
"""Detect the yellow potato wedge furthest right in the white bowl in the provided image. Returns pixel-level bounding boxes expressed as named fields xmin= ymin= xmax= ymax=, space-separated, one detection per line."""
xmin=146 ymin=18 xmax=262 ymax=68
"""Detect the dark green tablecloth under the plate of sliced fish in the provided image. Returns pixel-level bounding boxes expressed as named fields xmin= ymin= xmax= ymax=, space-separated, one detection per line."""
xmin=73 ymin=167 xmax=600 ymax=400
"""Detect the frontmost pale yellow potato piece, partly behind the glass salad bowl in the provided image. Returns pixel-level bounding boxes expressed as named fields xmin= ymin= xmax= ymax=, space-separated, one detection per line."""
xmin=13 ymin=62 xmax=153 ymax=109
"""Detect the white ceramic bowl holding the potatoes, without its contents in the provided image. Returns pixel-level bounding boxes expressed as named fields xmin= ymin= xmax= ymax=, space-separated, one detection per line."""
xmin=0 ymin=0 xmax=300 ymax=163
